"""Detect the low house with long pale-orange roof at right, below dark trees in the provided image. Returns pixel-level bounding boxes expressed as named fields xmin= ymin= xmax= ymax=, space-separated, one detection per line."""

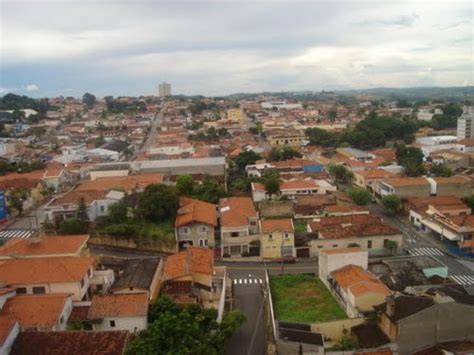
xmin=376 ymin=177 xmax=431 ymax=199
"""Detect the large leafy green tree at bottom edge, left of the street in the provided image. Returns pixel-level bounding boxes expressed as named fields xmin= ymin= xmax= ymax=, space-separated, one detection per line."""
xmin=126 ymin=299 xmax=245 ymax=355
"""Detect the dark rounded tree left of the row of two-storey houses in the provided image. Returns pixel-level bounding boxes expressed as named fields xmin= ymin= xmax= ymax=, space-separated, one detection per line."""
xmin=135 ymin=184 xmax=179 ymax=223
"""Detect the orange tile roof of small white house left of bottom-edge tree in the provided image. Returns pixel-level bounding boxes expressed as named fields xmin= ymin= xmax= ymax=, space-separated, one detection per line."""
xmin=87 ymin=293 xmax=148 ymax=319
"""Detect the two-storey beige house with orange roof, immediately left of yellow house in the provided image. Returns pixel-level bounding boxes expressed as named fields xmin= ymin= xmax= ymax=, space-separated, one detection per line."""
xmin=219 ymin=197 xmax=259 ymax=256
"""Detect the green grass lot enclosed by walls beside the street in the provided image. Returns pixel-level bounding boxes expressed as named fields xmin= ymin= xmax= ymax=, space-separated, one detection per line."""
xmin=270 ymin=275 xmax=347 ymax=323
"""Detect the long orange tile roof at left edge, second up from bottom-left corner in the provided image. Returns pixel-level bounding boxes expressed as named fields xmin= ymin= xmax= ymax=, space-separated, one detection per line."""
xmin=0 ymin=256 xmax=94 ymax=285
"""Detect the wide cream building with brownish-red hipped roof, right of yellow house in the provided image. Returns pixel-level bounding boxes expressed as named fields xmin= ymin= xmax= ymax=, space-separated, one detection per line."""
xmin=307 ymin=214 xmax=402 ymax=256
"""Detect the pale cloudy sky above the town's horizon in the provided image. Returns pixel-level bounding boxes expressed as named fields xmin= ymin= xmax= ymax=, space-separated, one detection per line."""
xmin=0 ymin=0 xmax=474 ymax=97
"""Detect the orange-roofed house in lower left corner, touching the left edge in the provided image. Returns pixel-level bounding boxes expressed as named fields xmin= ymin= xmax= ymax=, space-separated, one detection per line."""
xmin=0 ymin=293 xmax=72 ymax=331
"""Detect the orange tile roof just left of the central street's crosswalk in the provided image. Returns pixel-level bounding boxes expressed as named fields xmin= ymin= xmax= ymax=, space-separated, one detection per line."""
xmin=163 ymin=246 xmax=214 ymax=280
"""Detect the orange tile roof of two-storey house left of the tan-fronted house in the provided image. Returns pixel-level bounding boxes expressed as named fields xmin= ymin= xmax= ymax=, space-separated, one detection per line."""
xmin=175 ymin=197 xmax=217 ymax=227
